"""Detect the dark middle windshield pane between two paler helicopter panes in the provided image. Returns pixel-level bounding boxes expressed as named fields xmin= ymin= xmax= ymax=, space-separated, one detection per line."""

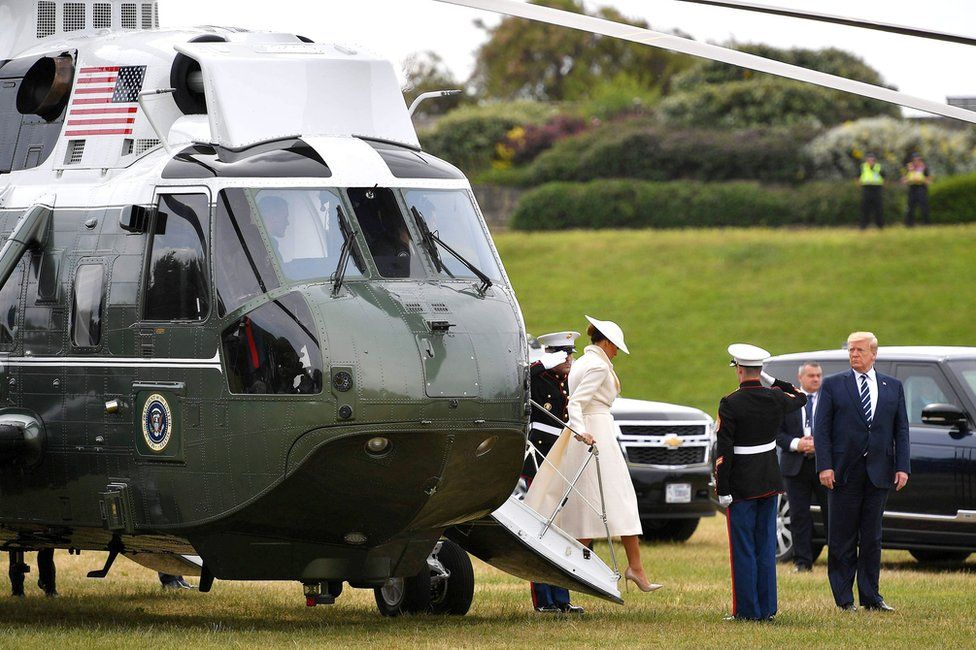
xmin=349 ymin=187 xmax=425 ymax=278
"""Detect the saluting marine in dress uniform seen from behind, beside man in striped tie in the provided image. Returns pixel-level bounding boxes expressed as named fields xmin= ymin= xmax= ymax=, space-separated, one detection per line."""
xmin=715 ymin=343 xmax=807 ymax=621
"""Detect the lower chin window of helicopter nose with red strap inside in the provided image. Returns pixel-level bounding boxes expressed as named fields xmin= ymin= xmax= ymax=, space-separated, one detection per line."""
xmin=223 ymin=293 xmax=323 ymax=395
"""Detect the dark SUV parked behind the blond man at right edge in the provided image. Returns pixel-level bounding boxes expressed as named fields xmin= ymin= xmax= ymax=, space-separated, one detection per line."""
xmin=765 ymin=346 xmax=976 ymax=562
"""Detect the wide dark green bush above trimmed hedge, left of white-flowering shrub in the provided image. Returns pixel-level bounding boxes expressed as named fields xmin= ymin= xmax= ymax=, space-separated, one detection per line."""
xmin=520 ymin=120 xmax=813 ymax=186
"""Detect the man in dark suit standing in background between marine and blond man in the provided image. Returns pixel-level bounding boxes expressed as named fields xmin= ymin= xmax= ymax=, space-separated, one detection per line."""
xmin=776 ymin=361 xmax=828 ymax=571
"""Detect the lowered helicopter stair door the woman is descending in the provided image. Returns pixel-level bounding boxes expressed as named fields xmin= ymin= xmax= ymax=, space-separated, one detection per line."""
xmin=444 ymin=495 xmax=623 ymax=603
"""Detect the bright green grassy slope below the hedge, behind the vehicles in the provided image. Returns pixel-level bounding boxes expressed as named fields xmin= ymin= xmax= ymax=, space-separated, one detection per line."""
xmin=495 ymin=226 xmax=976 ymax=415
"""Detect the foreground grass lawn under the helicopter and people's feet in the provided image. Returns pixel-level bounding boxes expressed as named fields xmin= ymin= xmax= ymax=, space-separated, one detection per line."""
xmin=0 ymin=516 xmax=976 ymax=650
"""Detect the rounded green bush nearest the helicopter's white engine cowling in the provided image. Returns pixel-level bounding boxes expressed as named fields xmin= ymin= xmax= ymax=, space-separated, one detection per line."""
xmin=419 ymin=102 xmax=558 ymax=176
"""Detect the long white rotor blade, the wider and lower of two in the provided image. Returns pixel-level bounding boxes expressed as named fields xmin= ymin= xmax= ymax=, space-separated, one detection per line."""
xmin=436 ymin=0 xmax=976 ymax=124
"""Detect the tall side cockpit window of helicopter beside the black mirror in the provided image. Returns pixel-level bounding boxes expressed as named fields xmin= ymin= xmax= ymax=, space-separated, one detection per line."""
xmin=145 ymin=194 xmax=210 ymax=321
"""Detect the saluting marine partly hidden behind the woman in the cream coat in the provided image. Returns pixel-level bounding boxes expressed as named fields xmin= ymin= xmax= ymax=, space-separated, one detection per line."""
xmin=522 ymin=332 xmax=583 ymax=614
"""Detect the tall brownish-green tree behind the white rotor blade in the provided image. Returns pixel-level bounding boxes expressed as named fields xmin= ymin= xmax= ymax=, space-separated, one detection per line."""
xmin=471 ymin=0 xmax=693 ymax=101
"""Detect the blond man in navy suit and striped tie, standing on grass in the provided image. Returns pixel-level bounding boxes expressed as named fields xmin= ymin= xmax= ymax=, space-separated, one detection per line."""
xmin=813 ymin=332 xmax=911 ymax=611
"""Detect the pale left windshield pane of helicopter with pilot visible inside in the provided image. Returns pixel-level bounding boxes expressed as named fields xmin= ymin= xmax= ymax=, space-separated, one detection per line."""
xmin=252 ymin=189 xmax=362 ymax=282
